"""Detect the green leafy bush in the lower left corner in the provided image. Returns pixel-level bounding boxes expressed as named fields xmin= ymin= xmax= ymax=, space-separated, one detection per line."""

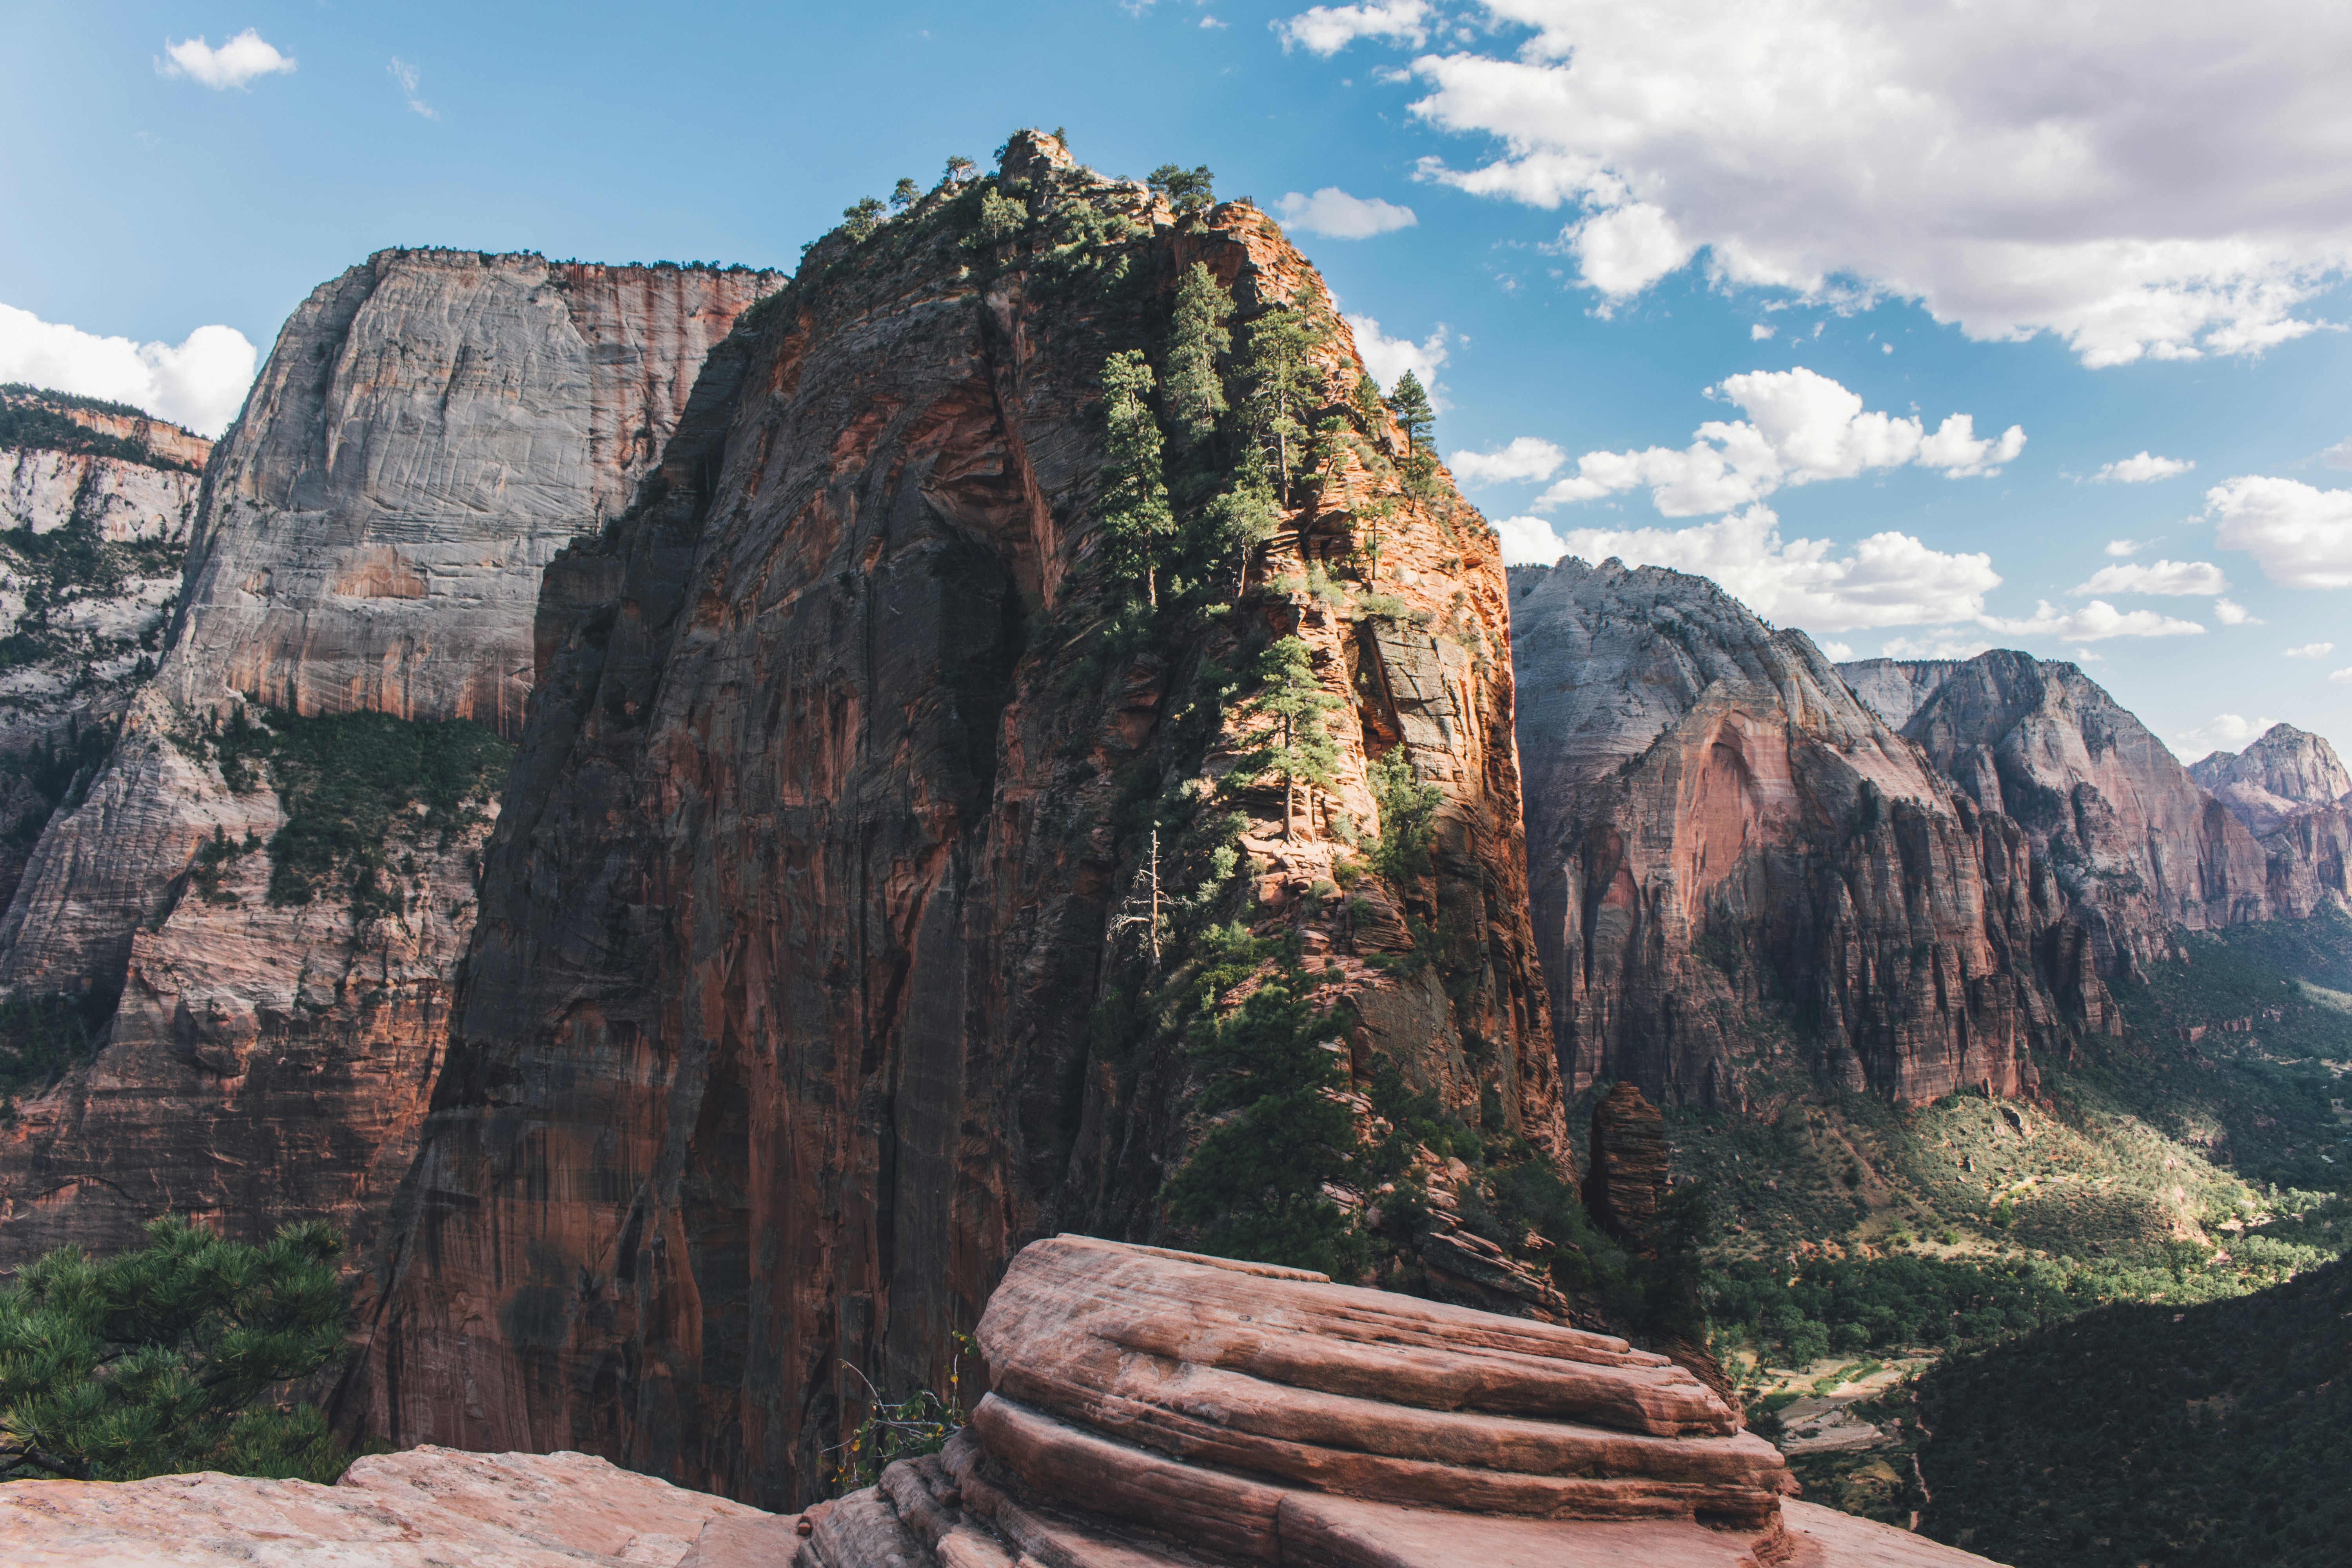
xmin=0 ymin=1218 xmax=350 ymax=1483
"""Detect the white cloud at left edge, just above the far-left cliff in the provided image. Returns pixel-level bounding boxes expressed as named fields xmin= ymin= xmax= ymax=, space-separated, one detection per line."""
xmin=0 ymin=306 xmax=254 ymax=435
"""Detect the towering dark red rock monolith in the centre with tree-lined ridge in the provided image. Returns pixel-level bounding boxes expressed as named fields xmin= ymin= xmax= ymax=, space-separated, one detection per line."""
xmin=346 ymin=134 xmax=1564 ymax=1502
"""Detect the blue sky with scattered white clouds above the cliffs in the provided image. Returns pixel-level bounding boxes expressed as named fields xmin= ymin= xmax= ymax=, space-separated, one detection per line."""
xmin=0 ymin=0 xmax=2352 ymax=757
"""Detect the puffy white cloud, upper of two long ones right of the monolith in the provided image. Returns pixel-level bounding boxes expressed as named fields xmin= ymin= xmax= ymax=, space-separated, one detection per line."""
xmin=1536 ymin=367 xmax=2025 ymax=517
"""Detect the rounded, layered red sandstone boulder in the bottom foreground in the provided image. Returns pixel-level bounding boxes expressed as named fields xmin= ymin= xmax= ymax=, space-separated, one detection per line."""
xmin=795 ymin=1236 xmax=1978 ymax=1568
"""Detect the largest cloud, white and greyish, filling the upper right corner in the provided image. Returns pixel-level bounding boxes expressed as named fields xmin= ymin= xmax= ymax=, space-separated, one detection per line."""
xmin=1374 ymin=0 xmax=2352 ymax=367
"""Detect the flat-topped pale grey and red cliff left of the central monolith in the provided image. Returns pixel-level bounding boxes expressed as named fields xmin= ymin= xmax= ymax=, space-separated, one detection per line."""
xmin=0 ymin=252 xmax=779 ymax=1262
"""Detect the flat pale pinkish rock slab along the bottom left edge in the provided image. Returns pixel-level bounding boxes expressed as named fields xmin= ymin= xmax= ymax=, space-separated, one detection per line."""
xmin=0 ymin=1448 xmax=771 ymax=1568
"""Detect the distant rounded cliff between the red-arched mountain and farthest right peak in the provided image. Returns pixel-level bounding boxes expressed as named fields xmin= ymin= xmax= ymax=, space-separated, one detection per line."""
xmin=1903 ymin=651 xmax=2270 ymax=973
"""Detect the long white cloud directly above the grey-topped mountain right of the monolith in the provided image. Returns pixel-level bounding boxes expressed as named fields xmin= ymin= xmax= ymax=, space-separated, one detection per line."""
xmin=1496 ymin=505 xmax=2002 ymax=632
